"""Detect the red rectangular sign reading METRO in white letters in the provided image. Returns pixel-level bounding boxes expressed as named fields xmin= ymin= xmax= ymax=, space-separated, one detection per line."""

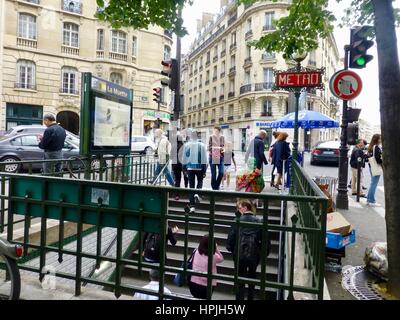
xmin=275 ymin=71 xmax=322 ymax=89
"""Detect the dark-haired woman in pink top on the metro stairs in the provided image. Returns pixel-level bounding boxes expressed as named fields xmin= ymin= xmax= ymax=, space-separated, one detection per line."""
xmin=189 ymin=235 xmax=224 ymax=299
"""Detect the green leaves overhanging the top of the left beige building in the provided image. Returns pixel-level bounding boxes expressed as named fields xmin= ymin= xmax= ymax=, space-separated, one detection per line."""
xmin=96 ymin=0 xmax=193 ymax=36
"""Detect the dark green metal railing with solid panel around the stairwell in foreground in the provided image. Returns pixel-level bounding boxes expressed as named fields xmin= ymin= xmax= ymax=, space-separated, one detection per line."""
xmin=0 ymin=163 xmax=327 ymax=299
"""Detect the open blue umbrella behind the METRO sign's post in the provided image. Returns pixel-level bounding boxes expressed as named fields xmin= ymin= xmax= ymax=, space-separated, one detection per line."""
xmin=269 ymin=110 xmax=339 ymax=129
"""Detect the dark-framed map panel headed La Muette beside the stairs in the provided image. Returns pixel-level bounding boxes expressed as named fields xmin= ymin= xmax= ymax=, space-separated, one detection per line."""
xmin=80 ymin=73 xmax=133 ymax=155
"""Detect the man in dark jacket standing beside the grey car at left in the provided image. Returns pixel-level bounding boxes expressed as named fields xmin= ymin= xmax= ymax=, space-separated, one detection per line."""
xmin=39 ymin=114 xmax=67 ymax=174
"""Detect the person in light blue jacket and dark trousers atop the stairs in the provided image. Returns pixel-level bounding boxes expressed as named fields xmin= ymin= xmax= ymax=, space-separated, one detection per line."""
xmin=182 ymin=131 xmax=207 ymax=213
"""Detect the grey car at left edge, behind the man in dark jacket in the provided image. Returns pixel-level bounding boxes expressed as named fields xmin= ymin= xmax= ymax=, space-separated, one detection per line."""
xmin=0 ymin=132 xmax=79 ymax=172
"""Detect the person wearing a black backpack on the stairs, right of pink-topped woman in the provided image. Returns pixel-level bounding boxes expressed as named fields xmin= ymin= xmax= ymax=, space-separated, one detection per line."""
xmin=226 ymin=200 xmax=270 ymax=300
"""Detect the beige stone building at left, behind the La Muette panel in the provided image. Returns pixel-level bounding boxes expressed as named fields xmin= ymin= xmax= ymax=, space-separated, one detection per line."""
xmin=0 ymin=0 xmax=173 ymax=135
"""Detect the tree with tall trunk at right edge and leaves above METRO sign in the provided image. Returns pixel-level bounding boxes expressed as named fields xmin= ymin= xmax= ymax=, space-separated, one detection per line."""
xmin=242 ymin=0 xmax=400 ymax=298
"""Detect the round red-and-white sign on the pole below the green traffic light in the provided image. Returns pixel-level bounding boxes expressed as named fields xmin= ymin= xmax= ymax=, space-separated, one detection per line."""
xmin=329 ymin=70 xmax=362 ymax=100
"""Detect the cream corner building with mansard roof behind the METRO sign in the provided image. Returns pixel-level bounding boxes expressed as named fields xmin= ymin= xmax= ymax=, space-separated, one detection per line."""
xmin=181 ymin=0 xmax=340 ymax=150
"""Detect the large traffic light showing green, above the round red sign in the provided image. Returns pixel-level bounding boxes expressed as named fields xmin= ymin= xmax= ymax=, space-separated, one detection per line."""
xmin=349 ymin=26 xmax=374 ymax=69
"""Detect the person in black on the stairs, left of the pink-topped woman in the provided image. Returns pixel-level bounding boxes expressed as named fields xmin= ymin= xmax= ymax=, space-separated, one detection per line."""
xmin=142 ymin=226 xmax=179 ymax=263
